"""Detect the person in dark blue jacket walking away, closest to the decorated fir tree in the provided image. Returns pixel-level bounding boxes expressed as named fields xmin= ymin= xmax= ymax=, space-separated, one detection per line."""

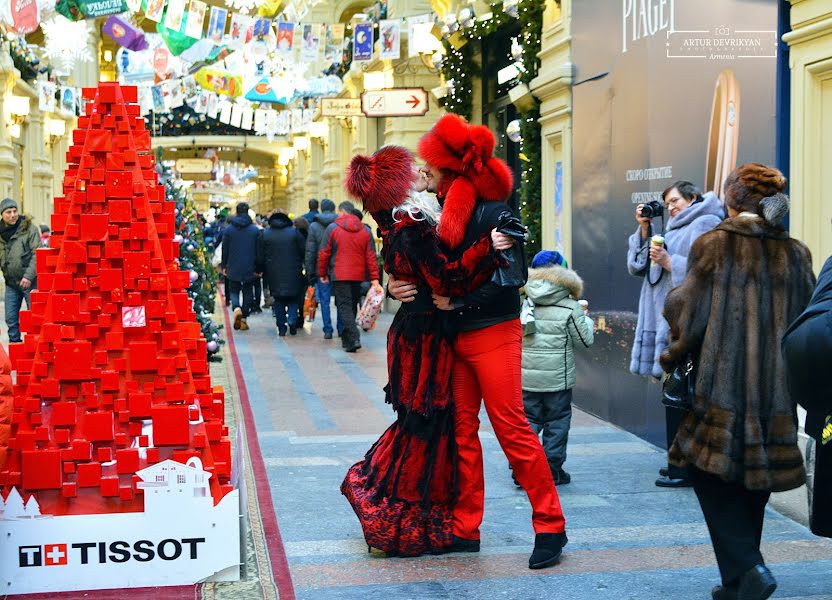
xmin=220 ymin=202 xmax=260 ymax=331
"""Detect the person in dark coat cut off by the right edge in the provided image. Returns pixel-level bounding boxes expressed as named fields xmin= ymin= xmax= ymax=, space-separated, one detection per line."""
xmin=783 ymin=257 xmax=832 ymax=537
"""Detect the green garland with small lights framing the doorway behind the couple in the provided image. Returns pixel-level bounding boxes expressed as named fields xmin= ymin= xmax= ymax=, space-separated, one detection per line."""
xmin=441 ymin=0 xmax=545 ymax=258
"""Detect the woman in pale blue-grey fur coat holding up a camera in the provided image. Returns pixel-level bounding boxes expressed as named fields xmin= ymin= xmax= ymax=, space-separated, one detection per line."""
xmin=627 ymin=181 xmax=725 ymax=487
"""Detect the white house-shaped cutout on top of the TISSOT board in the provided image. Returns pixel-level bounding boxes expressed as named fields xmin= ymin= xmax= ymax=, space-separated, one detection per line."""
xmin=136 ymin=457 xmax=214 ymax=513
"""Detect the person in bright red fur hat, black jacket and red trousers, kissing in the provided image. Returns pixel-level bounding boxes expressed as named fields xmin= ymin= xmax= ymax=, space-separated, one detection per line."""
xmin=390 ymin=114 xmax=567 ymax=569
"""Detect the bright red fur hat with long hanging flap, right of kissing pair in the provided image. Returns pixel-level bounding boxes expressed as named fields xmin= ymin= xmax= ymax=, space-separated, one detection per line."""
xmin=419 ymin=114 xmax=514 ymax=248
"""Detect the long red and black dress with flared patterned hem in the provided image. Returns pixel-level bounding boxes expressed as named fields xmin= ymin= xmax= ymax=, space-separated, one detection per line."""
xmin=341 ymin=212 xmax=499 ymax=556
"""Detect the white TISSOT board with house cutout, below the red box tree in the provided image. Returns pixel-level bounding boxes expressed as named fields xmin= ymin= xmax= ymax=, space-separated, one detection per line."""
xmin=0 ymin=460 xmax=240 ymax=596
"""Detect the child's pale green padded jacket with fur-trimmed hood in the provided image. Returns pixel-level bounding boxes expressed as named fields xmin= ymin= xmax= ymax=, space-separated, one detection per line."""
xmin=523 ymin=266 xmax=595 ymax=392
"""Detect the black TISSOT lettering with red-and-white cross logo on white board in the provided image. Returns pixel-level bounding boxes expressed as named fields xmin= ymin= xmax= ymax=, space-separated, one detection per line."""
xmin=18 ymin=538 xmax=205 ymax=567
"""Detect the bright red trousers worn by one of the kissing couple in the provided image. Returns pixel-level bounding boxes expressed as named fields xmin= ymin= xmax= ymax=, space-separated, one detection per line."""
xmin=452 ymin=319 xmax=566 ymax=540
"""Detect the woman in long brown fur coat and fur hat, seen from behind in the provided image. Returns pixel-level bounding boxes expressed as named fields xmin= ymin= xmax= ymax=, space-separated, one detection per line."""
xmin=661 ymin=163 xmax=815 ymax=600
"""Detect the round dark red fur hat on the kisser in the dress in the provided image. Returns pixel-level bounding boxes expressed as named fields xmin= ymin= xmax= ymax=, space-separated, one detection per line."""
xmin=344 ymin=146 xmax=414 ymax=212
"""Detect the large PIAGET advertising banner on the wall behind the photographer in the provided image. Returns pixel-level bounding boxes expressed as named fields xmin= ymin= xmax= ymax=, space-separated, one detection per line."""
xmin=569 ymin=0 xmax=777 ymax=444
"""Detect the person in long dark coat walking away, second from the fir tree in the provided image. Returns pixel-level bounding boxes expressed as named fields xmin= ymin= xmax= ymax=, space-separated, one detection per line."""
xmin=257 ymin=212 xmax=305 ymax=337
